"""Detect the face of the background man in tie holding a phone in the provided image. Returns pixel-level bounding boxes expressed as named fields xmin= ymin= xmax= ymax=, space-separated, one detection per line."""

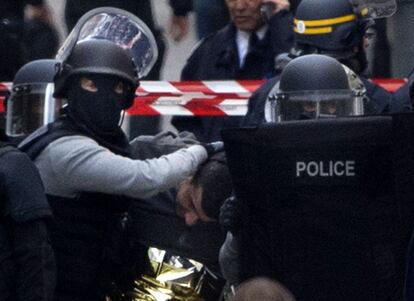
xmin=226 ymin=0 xmax=265 ymax=32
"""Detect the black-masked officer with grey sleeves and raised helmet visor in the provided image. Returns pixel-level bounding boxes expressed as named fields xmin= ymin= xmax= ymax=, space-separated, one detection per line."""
xmin=20 ymin=8 xmax=217 ymax=301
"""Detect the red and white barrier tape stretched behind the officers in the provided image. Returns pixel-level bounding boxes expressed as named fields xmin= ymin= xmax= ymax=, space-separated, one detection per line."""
xmin=0 ymin=79 xmax=405 ymax=116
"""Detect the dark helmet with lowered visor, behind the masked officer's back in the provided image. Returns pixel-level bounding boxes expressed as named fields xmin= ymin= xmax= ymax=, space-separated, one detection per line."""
xmin=6 ymin=59 xmax=61 ymax=137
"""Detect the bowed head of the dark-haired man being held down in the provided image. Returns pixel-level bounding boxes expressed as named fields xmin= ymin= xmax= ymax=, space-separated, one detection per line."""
xmin=177 ymin=153 xmax=232 ymax=226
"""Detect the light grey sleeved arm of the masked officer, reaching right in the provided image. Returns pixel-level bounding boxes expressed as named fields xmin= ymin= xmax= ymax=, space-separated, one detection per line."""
xmin=40 ymin=136 xmax=207 ymax=198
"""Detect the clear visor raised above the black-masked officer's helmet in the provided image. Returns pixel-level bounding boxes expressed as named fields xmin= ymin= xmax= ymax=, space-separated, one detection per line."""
xmin=57 ymin=7 xmax=158 ymax=78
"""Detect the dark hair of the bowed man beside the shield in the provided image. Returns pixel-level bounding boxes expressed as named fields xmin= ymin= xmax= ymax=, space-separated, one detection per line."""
xmin=192 ymin=152 xmax=233 ymax=219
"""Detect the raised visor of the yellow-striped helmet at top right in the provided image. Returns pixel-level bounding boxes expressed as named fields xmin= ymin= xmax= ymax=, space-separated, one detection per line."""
xmin=351 ymin=0 xmax=397 ymax=19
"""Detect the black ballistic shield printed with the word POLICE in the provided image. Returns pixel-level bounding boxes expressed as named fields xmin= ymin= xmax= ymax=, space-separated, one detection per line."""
xmin=222 ymin=114 xmax=414 ymax=301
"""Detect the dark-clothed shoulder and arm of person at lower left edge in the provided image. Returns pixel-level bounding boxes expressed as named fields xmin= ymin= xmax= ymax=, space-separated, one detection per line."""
xmin=0 ymin=143 xmax=56 ymax=301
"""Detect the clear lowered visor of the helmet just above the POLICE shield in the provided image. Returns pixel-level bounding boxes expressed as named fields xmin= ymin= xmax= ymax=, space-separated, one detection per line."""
xmin=272 ymin=90 xmax=363 ymax=122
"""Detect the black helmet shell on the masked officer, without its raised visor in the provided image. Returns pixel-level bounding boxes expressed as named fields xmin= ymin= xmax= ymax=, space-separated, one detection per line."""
xmin=55 ymin=39 xmax=138 ymax=109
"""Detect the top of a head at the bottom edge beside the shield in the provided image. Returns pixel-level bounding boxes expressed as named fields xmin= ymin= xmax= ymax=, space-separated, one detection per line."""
xmin=231 ymin=277 xmax=296 ymax=301
